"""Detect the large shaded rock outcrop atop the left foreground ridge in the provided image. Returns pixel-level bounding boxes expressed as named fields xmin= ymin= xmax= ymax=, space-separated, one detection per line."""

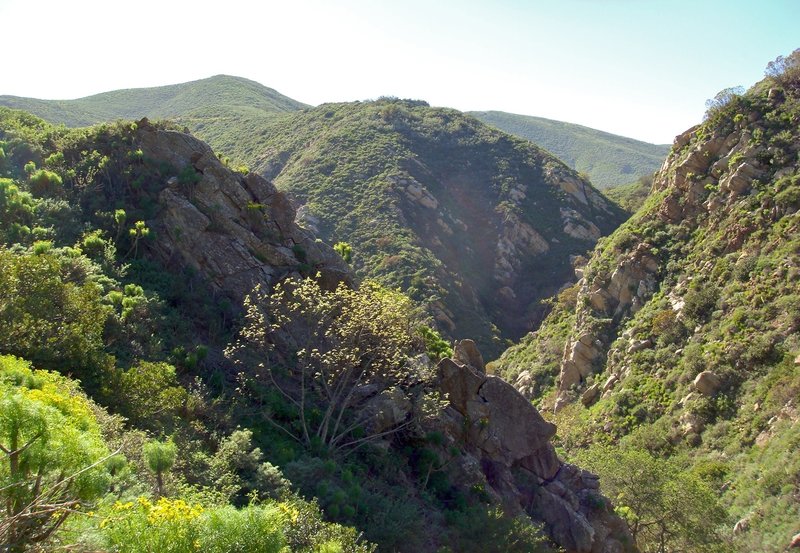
xmin=137 ymin=120 xmax=351 ymax=302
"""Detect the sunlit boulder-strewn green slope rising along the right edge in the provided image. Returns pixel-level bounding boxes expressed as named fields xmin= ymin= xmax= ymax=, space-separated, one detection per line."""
xmin=493 ymin=55 xmax=800 ymax=552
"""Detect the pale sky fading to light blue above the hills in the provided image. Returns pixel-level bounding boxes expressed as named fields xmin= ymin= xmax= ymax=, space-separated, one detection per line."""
xmin=0 ymin=0 xmax=800 ymax=144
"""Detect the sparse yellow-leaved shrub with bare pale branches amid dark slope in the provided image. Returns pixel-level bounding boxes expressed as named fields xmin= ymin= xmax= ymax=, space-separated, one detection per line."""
xmin=238 ymin=279 xmax=438 ymax=452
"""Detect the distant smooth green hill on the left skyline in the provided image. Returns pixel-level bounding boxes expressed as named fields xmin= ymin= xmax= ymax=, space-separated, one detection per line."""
xmin=0 ymin=75 xmax=307 ymax=164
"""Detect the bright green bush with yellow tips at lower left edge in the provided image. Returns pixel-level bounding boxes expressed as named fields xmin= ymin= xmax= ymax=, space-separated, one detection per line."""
xmin=0 ymin=356 xmax=110 ymax=551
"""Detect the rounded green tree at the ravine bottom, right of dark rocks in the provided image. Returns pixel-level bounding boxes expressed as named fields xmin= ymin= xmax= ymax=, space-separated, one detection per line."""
xmin=577 ymin=446 xmax=727 ymax=553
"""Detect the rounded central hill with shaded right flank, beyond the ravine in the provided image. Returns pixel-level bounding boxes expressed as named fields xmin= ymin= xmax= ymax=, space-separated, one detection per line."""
xmin=254 ymin=99 xmax=623 ymax=357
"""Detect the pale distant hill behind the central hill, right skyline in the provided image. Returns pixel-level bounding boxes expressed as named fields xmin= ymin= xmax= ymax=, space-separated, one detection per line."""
xmin=470 ymin=111 xmax=669 ymax=189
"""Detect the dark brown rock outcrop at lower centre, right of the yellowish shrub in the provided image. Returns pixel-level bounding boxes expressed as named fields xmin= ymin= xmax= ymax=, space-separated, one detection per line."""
xmin=437 ymin=347 xmax=635 ymax=553
